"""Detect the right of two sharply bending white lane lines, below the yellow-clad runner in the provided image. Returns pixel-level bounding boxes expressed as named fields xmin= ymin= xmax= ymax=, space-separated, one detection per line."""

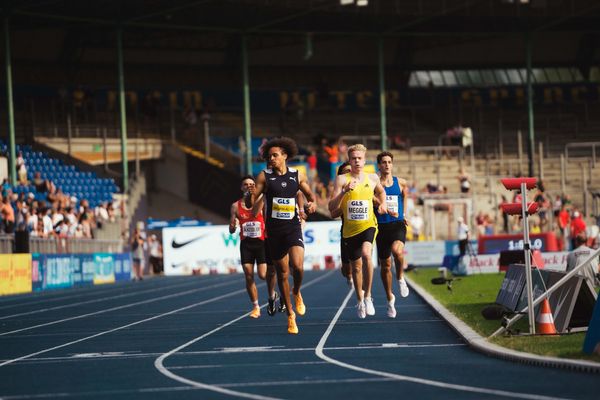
xmin=315 ymin=290 xmax=572 ymax=400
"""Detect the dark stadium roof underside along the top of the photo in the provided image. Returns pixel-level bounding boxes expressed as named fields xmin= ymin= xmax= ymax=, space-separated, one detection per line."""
xmin=4 ymin=0 xmax=600 ymax=36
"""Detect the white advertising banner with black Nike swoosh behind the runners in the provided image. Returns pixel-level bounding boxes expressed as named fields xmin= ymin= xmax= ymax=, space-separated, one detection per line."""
xmin=163 ymin=221 xmax=341 ymax=275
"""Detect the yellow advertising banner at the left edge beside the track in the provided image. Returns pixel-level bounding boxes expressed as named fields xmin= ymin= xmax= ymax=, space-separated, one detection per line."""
xmin=0 ymin=254 xmax=32 ymax=296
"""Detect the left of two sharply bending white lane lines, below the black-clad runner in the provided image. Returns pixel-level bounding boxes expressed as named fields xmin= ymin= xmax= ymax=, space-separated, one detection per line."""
xmin=154 ymin=270 xmax=333 ymax=400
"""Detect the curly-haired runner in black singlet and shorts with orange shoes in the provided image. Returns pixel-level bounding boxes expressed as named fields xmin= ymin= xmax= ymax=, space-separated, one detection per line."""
xmin=252 ymin=138 xmax=316 ymax=334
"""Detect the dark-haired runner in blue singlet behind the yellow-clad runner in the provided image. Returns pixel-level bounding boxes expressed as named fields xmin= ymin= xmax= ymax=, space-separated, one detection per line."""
xmin=375 ymin=151 xmax=409 ymax=318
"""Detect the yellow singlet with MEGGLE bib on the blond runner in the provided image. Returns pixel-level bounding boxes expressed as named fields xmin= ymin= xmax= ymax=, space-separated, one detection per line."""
xmin=340 ymin=174 xmax=377 ymax=238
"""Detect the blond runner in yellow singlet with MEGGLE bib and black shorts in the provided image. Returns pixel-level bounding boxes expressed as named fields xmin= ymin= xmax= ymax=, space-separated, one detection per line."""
xmin=329 ymin=144 xmax=387 ymax=318
